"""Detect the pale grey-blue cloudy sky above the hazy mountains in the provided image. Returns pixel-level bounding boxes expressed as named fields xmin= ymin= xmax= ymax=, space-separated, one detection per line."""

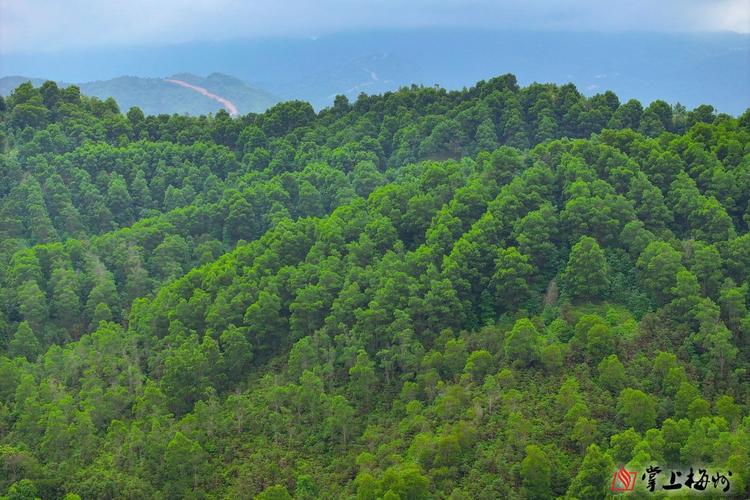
xmin=0 ymin=0 xmax=750 ymax=53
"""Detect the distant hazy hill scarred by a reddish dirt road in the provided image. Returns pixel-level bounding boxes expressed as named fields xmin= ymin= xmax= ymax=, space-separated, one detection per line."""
xmin=0 ymin=73 xmax=279 ymax=115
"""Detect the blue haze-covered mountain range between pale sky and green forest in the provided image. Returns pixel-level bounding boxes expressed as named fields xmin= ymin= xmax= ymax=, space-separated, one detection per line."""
xmin=0 ymin=28 xmax=750 ymax=115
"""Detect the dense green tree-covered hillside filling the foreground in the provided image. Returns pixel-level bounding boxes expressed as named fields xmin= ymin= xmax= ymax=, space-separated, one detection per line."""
xmin=0 ymin=75 xmax=750 ymax=500
